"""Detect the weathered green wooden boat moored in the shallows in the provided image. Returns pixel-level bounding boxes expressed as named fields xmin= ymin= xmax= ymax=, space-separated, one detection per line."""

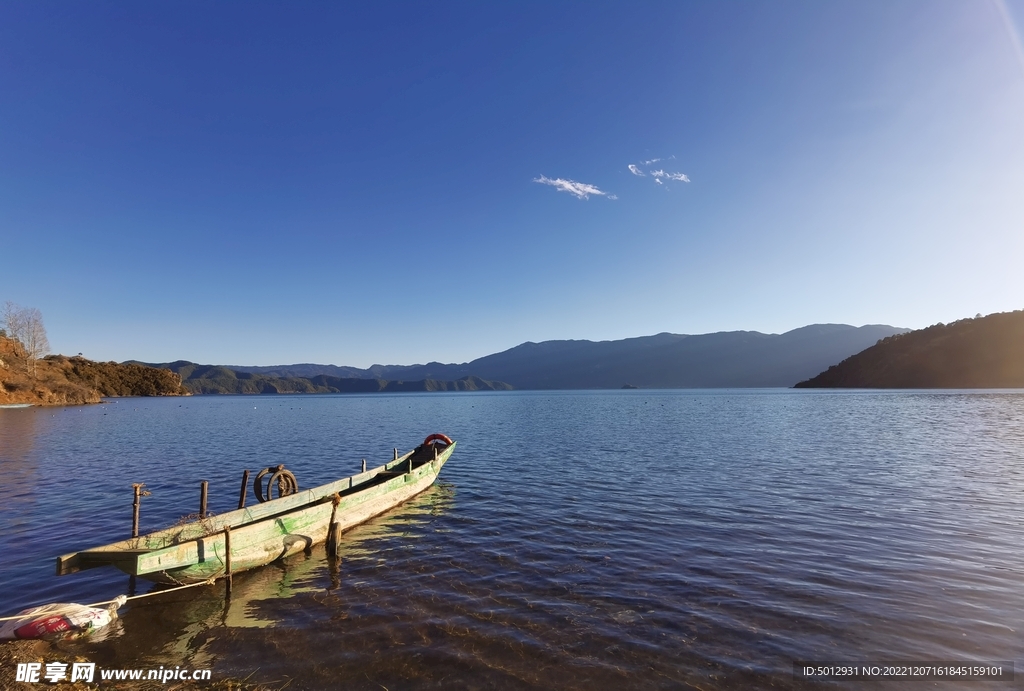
xmin=56 ymin=434 xmax=456 ymax=585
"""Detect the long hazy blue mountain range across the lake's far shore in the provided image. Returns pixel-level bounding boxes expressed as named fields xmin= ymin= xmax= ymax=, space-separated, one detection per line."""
xmin=153 ymin=323 xmax=908 ymax=393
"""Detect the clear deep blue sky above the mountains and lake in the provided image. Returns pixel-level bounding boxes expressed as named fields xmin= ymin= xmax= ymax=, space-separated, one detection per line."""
xmin=0 ymin=0 xmax=1024 ymax=366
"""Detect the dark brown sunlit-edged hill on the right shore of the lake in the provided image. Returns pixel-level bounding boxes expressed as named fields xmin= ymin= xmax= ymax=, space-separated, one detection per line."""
xmin=797 ymin=310 xmax=1024 ymax=389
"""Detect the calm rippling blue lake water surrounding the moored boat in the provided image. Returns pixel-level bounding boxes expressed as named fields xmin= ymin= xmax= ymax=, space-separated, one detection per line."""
xmin=0 ymin=390 xmax=1024 ymax=691
